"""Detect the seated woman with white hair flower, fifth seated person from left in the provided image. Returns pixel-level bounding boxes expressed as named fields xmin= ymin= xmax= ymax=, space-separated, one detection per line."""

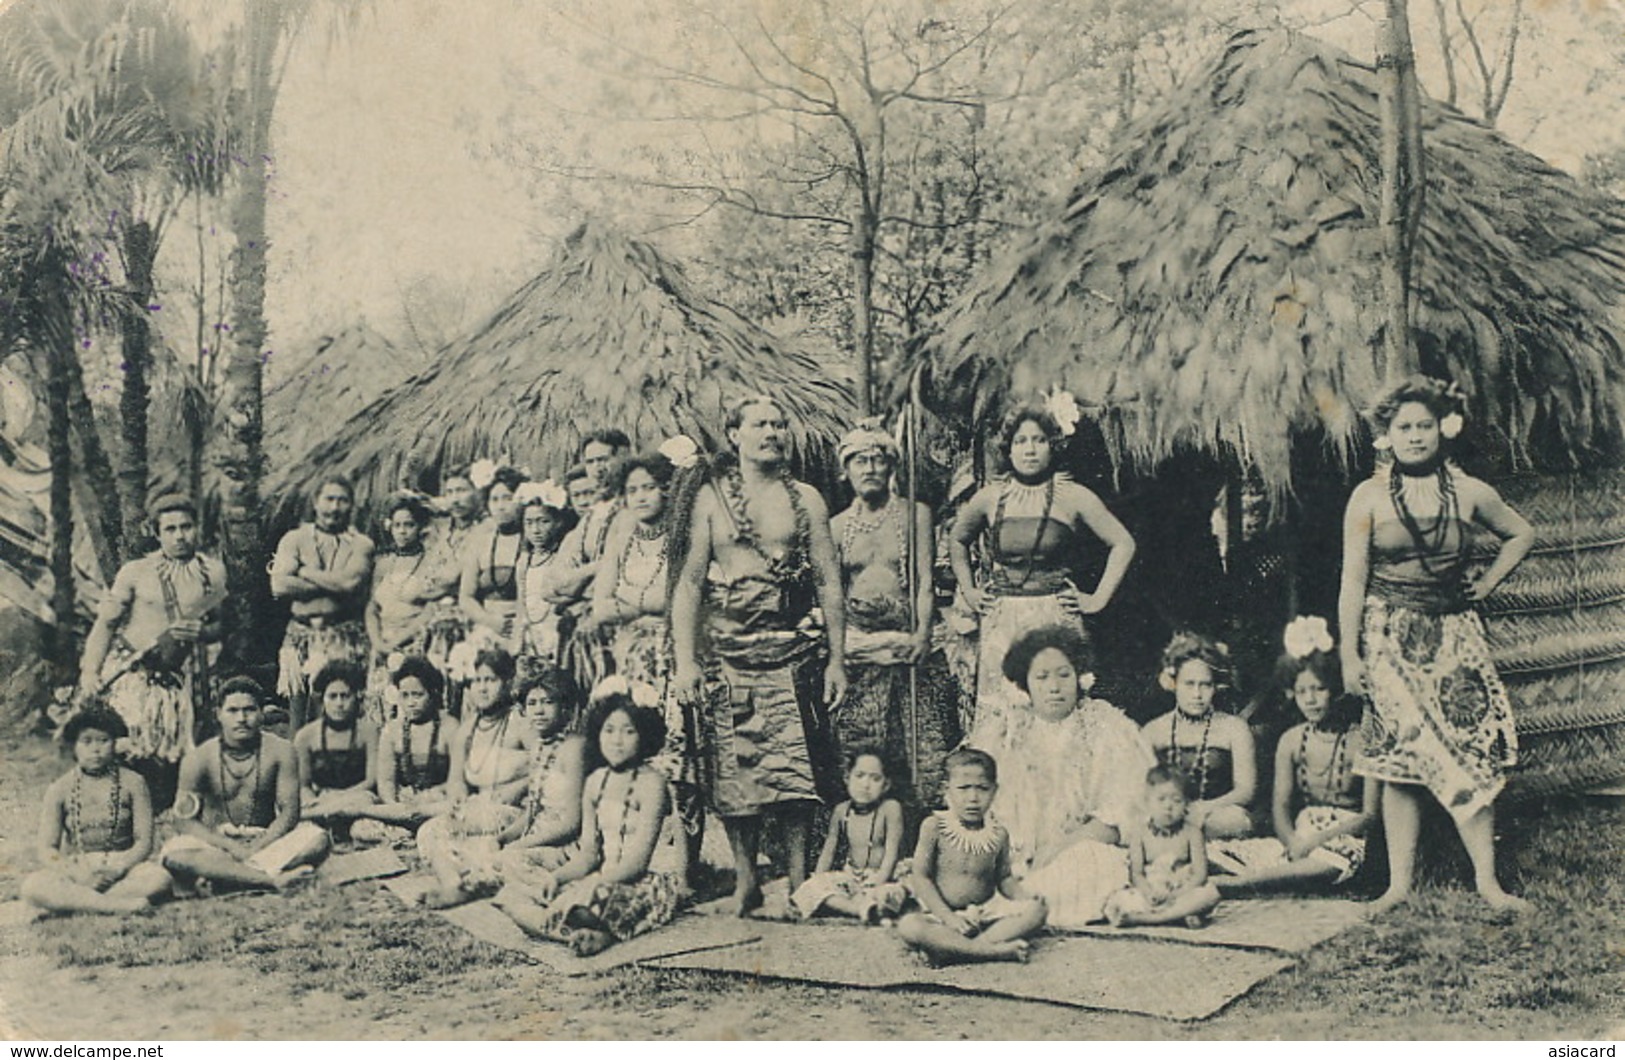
xmin=418 ymin=647 xmax=536 ymax=909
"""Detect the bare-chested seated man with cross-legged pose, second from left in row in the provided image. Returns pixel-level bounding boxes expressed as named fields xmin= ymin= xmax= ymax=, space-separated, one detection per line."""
xmin=161 ymin=678 xmax=328 ymax=894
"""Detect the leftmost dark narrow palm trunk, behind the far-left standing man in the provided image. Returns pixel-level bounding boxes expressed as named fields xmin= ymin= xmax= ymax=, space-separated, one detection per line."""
xmin=41 ymin=273 xmax=78 ymax=684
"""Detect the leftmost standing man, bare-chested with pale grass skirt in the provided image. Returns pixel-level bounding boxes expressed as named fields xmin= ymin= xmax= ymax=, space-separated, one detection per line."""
xmin=80 ymin=494 xmax=226 ymax=813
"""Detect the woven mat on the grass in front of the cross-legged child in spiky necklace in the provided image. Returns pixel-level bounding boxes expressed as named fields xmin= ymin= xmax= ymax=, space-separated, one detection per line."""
xmin=642 ymin=923 xmax=1292 ymax=1019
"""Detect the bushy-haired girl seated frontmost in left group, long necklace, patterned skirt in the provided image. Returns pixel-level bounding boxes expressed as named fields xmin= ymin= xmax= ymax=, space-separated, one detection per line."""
xmin=496 ymin=682 xmax=686 ymax=956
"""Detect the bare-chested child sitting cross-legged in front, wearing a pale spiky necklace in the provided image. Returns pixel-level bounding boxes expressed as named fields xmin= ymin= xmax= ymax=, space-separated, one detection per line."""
xmin=897 ymin=748 xmax=1047 ymax=962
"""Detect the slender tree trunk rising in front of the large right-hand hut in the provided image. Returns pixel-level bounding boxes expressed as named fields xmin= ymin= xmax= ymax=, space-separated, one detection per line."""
xmin=1376 ymin=0 xmax=1425 ymax=382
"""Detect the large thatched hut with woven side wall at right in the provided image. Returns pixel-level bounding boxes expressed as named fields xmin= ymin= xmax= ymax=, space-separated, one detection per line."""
xmin=931 ymin=33 xmax=1625 ymax=790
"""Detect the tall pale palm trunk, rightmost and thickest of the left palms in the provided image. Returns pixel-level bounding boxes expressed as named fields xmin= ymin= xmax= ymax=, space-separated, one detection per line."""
xmin=210 ymin=0 xmax=276 ymax=665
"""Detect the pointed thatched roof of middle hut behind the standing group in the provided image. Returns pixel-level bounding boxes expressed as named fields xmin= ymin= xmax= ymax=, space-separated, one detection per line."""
xmin=270 ymin=223 xmax=855 ymax=501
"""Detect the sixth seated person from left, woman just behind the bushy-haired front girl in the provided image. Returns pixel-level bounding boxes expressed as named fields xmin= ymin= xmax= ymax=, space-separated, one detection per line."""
xmin=497 ymin=668 xmax=587 ymax=884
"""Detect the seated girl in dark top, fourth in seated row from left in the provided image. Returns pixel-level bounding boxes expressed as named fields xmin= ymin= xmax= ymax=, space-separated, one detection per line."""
xmin=353 ymin=655 xmax=457 ymax=842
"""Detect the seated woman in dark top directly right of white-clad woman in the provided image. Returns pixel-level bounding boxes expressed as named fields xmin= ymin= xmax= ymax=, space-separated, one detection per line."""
xmin=1141 ymin=632 xmax=1258 ymax=839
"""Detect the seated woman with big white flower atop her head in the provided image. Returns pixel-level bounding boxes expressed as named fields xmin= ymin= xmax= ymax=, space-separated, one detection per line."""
xmin=1212 ymin=618 xmax=1378 ymax=894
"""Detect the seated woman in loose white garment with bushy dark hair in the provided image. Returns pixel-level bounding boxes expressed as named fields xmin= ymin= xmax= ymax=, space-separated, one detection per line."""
xmin=999 ymin=624 xmax=1155 ymax=930
